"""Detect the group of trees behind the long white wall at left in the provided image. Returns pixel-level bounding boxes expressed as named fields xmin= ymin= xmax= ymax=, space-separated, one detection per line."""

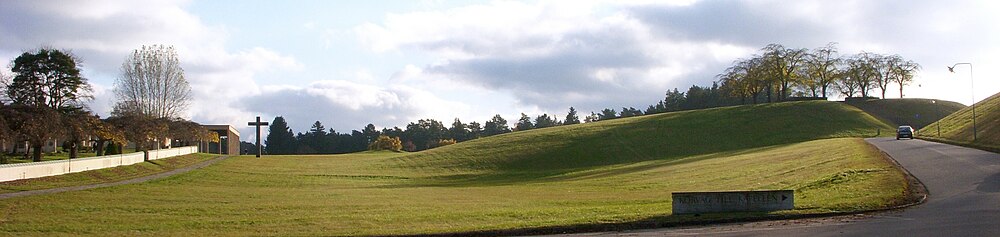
xmin=0 ymin=45 xmax=219 ymax=163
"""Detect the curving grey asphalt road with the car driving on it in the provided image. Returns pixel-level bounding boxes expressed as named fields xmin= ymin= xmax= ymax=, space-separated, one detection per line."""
xmin=564 ymin=138 xmax=1000 ymax=236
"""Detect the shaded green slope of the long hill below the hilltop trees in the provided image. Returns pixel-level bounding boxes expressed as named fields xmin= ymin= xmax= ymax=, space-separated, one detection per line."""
xmin=397 ymin=101 xmax=892 ymax=177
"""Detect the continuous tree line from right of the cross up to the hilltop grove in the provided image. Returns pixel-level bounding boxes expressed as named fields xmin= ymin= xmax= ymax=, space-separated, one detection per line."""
xmin=265 ymin=43 xmax=920 ymax=154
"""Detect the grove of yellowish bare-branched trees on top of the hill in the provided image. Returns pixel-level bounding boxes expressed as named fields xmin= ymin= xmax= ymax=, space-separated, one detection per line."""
xmin=718 ymin=43 xmax=920 ymax=103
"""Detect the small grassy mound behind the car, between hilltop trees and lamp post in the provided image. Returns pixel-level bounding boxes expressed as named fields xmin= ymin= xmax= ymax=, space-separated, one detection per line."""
xmin=847 ymin=99 xmax=965 ymax=129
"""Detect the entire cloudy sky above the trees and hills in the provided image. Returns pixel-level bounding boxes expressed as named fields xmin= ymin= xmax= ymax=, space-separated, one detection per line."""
xmin=0 ymin=0 xmax=1000 ymax=141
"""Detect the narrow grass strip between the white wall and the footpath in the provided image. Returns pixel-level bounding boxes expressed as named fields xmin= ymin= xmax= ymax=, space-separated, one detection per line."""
xmin=0 ymin=153 xmax=218 ymax=193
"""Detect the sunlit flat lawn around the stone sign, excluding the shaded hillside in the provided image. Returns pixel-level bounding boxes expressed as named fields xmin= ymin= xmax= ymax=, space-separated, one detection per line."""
xmin=0 ymin=138 xmax=906 ymax=236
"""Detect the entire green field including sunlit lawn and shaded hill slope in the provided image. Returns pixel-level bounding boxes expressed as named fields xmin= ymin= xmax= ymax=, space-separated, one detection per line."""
xmin=0 ymin=102 xmax=907 ymax=236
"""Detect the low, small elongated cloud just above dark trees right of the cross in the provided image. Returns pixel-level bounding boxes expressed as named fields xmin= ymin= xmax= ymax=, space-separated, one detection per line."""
xmin=241 ymin=80 xmax=469 ymax=132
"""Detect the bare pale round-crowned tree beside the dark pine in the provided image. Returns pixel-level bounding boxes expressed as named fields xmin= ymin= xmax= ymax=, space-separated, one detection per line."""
xmin=115 ymin=45 xmax=191 ymax=118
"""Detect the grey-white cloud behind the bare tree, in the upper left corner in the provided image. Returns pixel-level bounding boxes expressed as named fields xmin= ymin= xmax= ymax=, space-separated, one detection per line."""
xmin=0 ymin=1 xmax=303 ymax=138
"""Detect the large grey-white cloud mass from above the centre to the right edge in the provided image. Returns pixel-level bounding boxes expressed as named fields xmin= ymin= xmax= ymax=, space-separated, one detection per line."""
xmin=355 ymin=1 xmax=998 ymax=111
